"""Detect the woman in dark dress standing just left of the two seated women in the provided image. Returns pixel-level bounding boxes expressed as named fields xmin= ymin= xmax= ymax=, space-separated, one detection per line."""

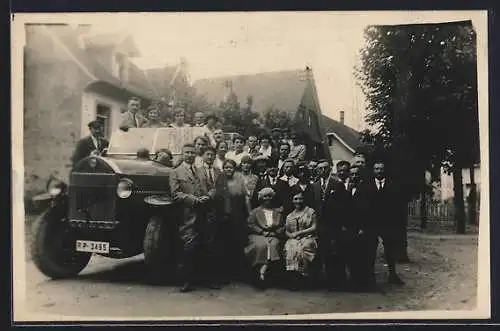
xmin=215 ymin=160 xmax=250 ymax=282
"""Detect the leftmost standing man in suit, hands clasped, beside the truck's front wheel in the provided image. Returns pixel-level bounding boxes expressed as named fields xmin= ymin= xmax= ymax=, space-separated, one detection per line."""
xmin=169 ymin=144 xmax=210 ymax=292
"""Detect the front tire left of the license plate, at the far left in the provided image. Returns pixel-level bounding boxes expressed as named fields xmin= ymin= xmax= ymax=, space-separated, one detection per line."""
xmin=31 ymin=208 xmax=92 ymax=279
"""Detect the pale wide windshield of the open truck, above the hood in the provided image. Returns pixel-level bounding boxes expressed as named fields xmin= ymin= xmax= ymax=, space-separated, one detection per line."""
xmin=108 ymin=127 xmax=203 ymax=155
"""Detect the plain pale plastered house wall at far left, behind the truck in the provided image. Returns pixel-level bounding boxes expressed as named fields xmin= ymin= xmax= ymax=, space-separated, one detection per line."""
xmin=24 ymin=26 xmax=90 ymax=197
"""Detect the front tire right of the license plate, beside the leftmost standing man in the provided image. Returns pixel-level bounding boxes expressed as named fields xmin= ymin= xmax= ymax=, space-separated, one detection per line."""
xmin=143 ymin=216 xmax=174 ymax=282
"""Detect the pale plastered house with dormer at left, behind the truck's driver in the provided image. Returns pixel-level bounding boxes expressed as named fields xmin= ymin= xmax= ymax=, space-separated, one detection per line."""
xmin=24 ymin=24 xmax=183 ymax=196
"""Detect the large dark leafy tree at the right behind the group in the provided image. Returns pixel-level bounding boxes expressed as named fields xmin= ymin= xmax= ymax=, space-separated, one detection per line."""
xmin=356 ymin=22 xmax=479 ymax=233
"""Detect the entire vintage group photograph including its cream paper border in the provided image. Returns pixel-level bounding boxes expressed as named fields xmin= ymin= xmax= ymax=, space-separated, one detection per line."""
xmin=12 ymin=11 xmax=490 ymax=321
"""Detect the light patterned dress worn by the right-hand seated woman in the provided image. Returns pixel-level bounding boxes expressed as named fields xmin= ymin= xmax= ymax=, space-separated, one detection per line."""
xmin=285 ymin=207 xmax=318 ymax=276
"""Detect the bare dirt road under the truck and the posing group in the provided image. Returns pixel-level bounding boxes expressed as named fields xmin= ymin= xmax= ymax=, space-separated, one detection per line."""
xmin=18 ymin=233 xmax=477 ymax=319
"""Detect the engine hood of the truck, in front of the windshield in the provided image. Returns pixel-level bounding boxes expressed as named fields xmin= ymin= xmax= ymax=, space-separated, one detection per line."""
xmin=100 ymin=157 xmax=171 ymax=176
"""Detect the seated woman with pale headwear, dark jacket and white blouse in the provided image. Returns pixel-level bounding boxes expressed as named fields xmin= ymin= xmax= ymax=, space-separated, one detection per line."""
xmin=245 ymin=187 xmax=284 ymax=285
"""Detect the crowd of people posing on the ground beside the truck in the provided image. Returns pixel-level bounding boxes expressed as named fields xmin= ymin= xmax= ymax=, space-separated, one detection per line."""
xmin=166 ymin=131 xmax=403 ymax=292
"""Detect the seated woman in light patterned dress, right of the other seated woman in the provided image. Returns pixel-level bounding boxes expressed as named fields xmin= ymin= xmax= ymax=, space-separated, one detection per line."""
xmin=285 ymin=188 xmax=318 ymax=289
